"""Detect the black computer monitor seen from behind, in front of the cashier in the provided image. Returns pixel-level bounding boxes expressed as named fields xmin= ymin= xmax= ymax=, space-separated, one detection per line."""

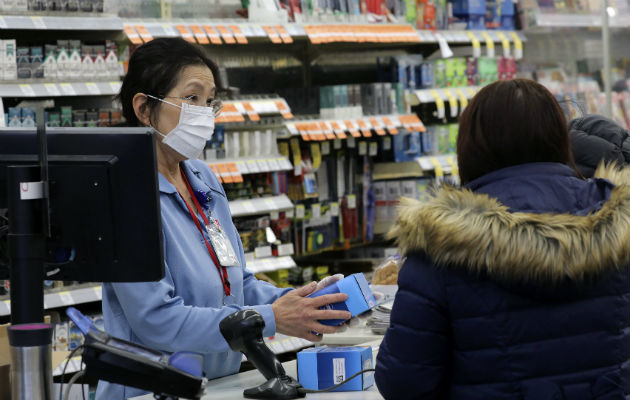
xmin=0 ymin=128 xmax=164 ymax=282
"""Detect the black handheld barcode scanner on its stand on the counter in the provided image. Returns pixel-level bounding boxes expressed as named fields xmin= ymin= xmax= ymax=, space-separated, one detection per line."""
xmin=219 ymin=310 xmax=306 ymax=400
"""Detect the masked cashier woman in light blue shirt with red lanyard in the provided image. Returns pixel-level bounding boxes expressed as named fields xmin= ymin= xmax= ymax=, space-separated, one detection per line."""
xmin=96 ymin=39 xmax=350 ymax=400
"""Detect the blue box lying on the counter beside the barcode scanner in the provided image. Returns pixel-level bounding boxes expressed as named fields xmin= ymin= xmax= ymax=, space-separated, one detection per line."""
xmin=297 ymin=346 xmax=374 ymax=392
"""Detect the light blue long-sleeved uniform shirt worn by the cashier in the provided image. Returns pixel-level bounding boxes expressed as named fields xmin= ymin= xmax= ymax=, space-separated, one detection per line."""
xmin=96 ymin=160 xmax=290 ymax=400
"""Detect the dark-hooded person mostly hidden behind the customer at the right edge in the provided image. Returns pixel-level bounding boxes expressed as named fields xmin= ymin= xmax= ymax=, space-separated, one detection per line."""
xmin=569 ymin=115 xmax=630 ymax=178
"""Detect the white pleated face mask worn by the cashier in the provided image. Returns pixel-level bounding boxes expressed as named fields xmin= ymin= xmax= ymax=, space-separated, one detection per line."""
xmin=147 ymin=94 xmax=214 ymax=160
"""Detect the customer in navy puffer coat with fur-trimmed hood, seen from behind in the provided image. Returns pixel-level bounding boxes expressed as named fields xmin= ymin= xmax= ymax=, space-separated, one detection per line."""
xmin=376 ymin=79 xmax=630 ymax=400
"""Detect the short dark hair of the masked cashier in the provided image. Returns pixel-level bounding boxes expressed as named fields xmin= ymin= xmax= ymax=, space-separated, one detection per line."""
xmin=118 ymin=38 xmax=222 ymax=126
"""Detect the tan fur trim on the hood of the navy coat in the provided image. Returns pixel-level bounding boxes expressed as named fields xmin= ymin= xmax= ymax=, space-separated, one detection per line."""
xmin=388 ymin=165 xmax=630 ymax=282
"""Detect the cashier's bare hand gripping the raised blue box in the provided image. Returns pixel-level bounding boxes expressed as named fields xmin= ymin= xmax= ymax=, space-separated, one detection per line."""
xmin=271 ymin=282 xmax=352 ymax=342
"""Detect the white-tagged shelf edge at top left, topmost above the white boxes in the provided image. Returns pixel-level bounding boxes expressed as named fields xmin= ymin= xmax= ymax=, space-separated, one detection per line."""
xmin=0 ymin=15 xmax=123 ymax=31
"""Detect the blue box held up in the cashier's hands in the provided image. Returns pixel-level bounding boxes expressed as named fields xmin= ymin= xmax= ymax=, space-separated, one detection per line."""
xmin=308 ymin=272 xmax=378 ymax=326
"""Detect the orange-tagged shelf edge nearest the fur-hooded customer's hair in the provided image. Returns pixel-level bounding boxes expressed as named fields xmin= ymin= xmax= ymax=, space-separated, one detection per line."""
xmin=285 ymin=114 xmax=426 ymax=141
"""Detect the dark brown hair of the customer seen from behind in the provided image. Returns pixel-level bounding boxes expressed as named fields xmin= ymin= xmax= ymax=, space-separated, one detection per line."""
xmin=457 ymin=79 xmax=580 ymax=184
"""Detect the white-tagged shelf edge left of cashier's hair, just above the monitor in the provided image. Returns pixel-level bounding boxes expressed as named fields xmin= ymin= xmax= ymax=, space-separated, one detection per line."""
xmin=0 ymin=81 xmax=122 ymax=97
